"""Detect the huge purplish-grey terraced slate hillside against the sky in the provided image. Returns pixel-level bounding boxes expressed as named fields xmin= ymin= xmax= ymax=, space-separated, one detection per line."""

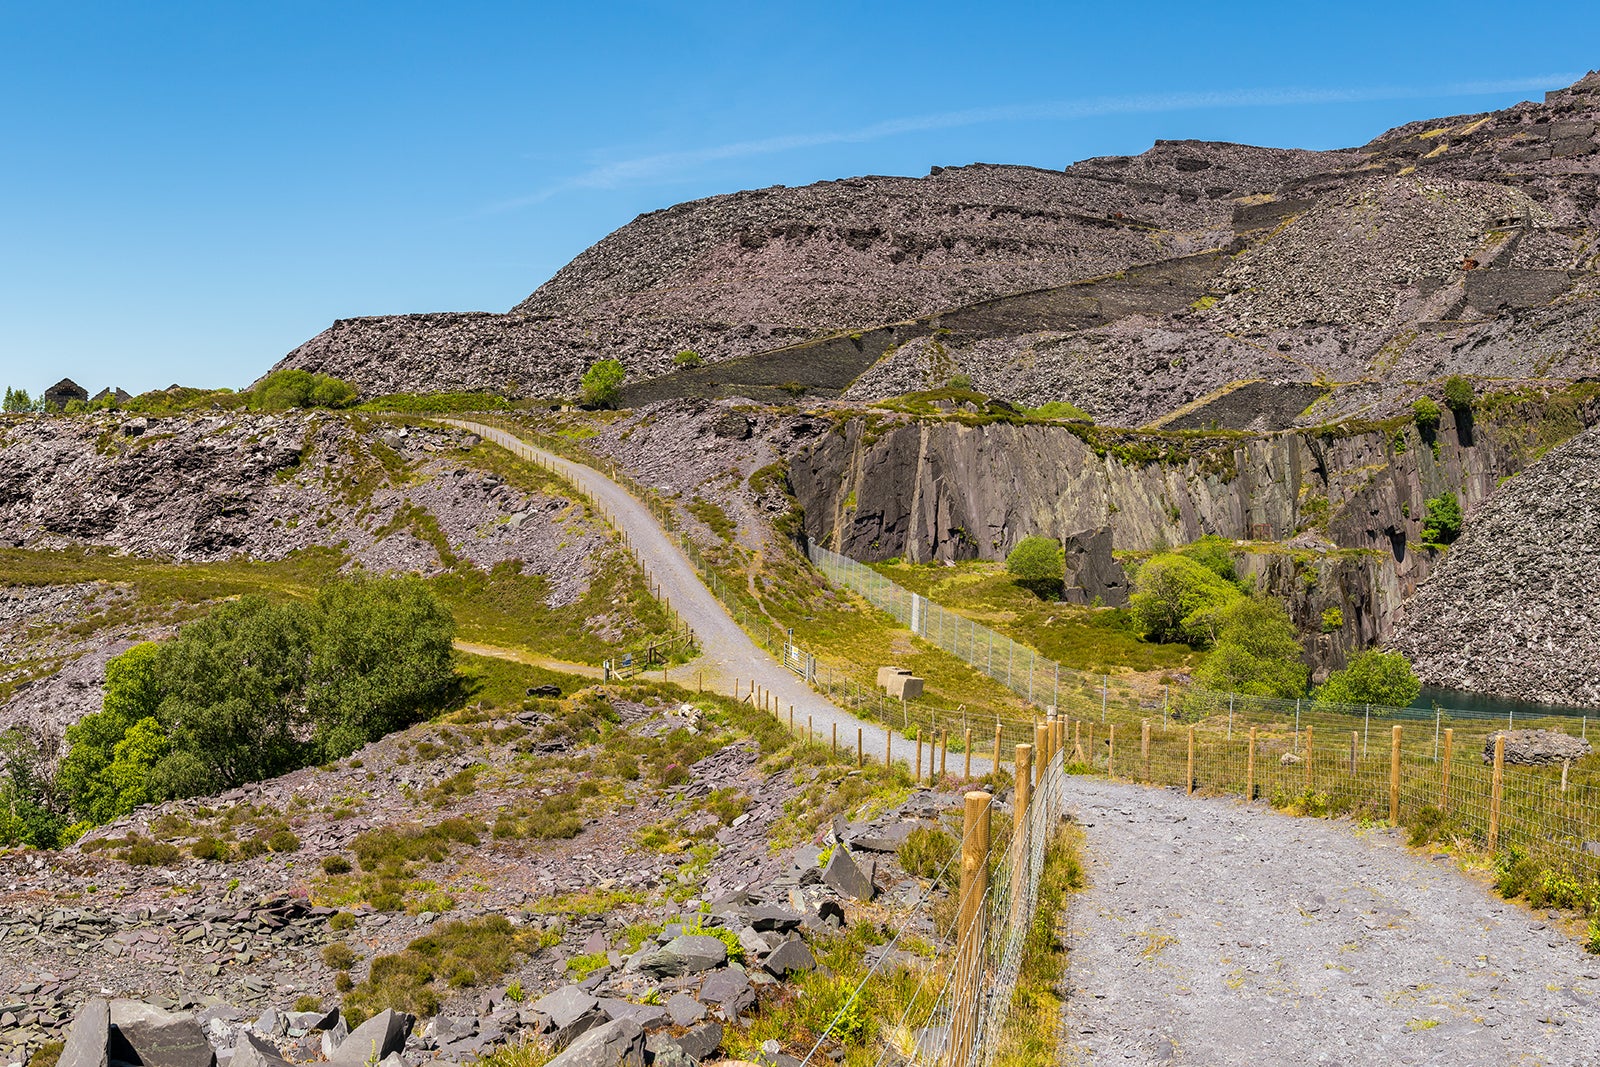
xmin=280 ymin=74 xmax=1600 ymax=424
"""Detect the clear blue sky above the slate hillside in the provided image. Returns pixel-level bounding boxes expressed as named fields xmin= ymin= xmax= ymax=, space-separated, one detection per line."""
xmin=0 ymin=0 xmax=1600 ymax=392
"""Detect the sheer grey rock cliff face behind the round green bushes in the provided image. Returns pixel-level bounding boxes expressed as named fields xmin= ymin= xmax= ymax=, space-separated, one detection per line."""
xmin=790 ymin=389 xmax=1600 ymax=662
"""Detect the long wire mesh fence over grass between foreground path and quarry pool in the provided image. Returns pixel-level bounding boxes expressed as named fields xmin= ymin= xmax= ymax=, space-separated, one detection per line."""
xmin=808 ymin=544 xmax=1600 ymax=880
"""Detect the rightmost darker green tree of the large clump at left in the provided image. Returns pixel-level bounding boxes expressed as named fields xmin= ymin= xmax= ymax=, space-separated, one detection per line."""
xmin=307 ymin=577 xmax=456 ymax=760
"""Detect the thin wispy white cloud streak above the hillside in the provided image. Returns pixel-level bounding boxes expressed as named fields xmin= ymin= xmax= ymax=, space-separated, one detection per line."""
xmin=488 ymin=74 xmax=1582 ymax=213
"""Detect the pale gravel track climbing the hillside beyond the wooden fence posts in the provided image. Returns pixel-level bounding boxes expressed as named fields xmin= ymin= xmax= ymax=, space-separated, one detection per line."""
xmin=440 ymin=419 xmax=990 ymax=774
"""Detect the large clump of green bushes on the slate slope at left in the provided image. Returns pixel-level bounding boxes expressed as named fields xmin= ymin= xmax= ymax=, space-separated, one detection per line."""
xmin=56 ymin=577 xmax=458 ymax=825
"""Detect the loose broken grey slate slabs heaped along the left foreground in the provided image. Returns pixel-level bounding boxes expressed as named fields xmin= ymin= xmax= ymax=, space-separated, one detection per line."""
xmin=12 ymin=792 xmax=979 ymax=1067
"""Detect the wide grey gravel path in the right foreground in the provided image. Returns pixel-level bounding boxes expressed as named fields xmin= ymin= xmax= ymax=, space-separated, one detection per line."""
xmin=1064 ymin=777 xmax=1600 ymax=1067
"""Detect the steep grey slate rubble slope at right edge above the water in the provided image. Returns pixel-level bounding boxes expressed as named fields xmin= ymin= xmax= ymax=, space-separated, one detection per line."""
xmin=1392 ymin=429 xmax=1600 ymax=707
